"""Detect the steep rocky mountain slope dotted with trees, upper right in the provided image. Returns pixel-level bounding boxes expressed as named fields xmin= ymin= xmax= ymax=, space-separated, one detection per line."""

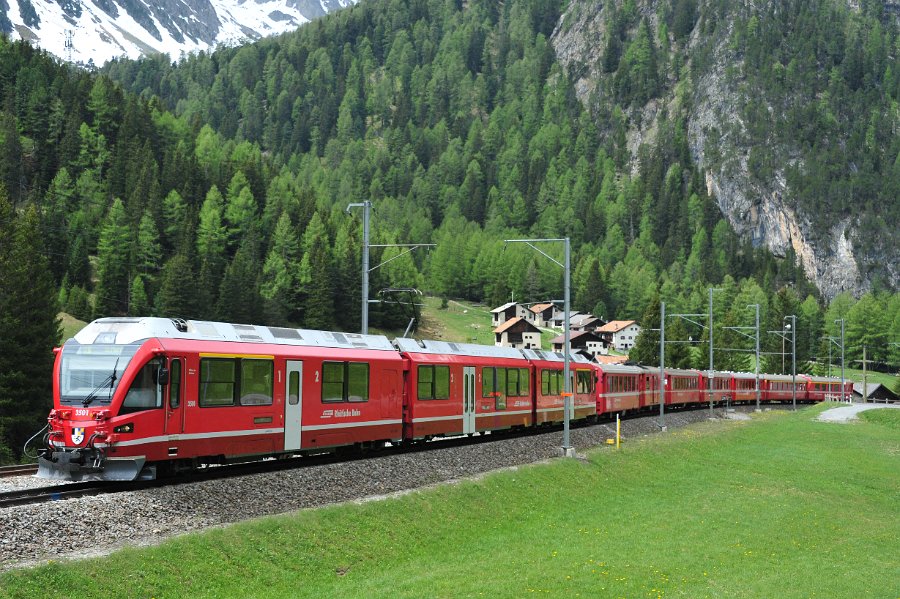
xmin=553 ymin=0 xmax=900 ymax=298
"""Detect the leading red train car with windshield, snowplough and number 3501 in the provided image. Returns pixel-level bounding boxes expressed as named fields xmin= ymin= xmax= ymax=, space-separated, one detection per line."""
xmin=39 ymin=318 xmax=403 ymax=480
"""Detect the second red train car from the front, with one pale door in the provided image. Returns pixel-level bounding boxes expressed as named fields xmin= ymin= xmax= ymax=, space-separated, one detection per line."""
xmin=394 ymin=338 xmax=534 ymax=440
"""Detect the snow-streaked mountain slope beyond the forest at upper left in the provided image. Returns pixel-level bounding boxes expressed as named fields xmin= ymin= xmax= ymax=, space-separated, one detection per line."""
xmin=0 ymin=0 xmax=355 ymax=65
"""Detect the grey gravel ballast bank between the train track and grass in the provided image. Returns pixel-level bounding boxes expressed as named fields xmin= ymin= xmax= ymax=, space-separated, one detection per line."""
xmin=0 ymin=408 xmax=749 ymax=572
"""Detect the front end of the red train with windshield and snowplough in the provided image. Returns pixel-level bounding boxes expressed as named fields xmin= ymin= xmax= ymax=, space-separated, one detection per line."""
xmin=38 ymin=318 xmax=166 ymax=480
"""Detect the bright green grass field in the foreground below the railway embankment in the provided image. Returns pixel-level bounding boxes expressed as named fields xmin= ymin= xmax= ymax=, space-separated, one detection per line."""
xmin=0 ymin=408 xmax=900 ymax=598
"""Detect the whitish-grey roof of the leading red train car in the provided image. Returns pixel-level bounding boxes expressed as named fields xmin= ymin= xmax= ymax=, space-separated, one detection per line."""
xmin=75 ymin=317 xmax=395 ymax=351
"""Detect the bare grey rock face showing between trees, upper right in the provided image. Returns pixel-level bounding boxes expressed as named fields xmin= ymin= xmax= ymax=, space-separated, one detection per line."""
xmin=552 ymin=0 xmax=900 ymax=299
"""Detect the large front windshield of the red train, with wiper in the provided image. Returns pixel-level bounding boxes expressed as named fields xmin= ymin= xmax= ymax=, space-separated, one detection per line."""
xmin=59 ymin=341 xmax=141 ymax=407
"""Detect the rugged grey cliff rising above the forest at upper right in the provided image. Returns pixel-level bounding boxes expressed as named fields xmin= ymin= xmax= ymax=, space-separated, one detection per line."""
xmin=552 ymin=0 xmax=900 ymax=298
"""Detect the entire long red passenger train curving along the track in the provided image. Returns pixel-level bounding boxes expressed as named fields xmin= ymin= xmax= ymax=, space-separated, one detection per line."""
xmin=39 ymin=318 xmax=850 ymax=480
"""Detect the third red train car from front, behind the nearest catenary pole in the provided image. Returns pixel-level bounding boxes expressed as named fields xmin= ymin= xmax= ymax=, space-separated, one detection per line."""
xmin=521 ymin=349 xmax=597 ymax=424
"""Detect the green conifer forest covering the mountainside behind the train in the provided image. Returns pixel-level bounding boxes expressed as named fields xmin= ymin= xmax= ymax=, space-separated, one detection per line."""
xmin=0 ymin=0 xmax=900 ymax=463
